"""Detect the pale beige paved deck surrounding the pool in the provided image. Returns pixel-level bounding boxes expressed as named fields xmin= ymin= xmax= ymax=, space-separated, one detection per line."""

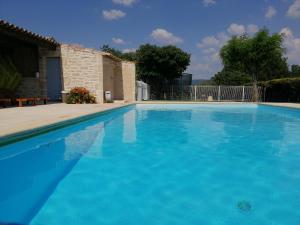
xmin=0 ymin=101 xmax=300 ymax=145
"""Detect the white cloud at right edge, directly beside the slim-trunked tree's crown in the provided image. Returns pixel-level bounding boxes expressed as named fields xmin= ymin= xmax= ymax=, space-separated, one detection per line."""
xmin=280 ymin=27 xmax=300 ymax=64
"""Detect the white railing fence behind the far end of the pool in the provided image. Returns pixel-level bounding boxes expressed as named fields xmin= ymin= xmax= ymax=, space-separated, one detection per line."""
xmin=158 ymin=85 xmax=265 ymax=102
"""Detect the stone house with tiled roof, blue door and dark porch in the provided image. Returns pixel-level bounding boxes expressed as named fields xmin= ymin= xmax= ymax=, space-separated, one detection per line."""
xmin=0 ymin=20 xmax=135 ymax=103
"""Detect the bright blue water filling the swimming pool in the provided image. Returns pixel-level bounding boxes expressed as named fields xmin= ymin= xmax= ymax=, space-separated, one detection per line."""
xmin=0 ymin=104 xmax=300 ymax=225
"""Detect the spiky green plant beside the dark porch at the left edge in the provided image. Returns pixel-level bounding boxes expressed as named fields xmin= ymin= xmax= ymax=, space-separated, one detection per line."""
xmin=0 ymin=55 xmax=22 ymax=97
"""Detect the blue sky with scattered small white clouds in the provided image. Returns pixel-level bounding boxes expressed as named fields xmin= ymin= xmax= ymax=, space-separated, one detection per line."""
xmin=0 ymin=0 xmax=300 ymax=79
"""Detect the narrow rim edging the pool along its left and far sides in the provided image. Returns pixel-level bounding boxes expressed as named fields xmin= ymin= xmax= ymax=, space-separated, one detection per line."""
xmin=0 ymin=101 xmax=300 ymax=146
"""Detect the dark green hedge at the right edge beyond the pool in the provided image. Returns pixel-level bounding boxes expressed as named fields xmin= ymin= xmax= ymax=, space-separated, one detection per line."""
xmin=260 ymin=78 xmax=300 ymax=102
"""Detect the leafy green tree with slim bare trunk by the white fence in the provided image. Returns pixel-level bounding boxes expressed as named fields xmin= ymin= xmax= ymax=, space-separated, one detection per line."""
xmin=216 ymin=29 xmax=288 ymax=101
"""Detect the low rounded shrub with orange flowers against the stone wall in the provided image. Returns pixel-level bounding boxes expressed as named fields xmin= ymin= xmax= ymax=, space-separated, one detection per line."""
xmin=67 ymin=87 xmax=96 ymax=104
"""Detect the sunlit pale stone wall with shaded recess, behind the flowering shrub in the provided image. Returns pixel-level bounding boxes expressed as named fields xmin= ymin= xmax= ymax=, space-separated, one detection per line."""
xmin=61 ymin=45 xmax=135 ymax=103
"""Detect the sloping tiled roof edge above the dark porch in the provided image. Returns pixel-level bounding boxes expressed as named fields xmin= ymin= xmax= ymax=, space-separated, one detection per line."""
xmin=0 ymin=20 xmax=60 ymax=48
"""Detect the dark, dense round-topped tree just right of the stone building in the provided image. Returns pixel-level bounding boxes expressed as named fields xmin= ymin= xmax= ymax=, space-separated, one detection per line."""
xmin=137 ymin=44 xmax=190 ymax=95
